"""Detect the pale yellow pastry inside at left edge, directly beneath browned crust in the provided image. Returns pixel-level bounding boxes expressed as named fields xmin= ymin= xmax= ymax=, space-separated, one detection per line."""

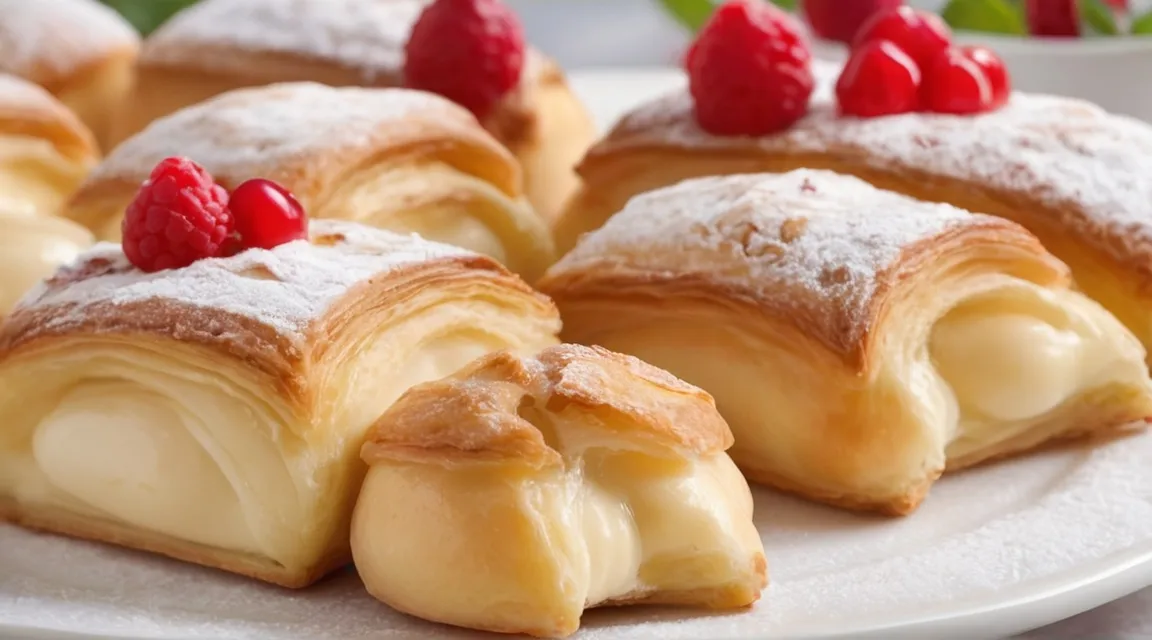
xmin=0 ymin=136 xmax=88 ymax=215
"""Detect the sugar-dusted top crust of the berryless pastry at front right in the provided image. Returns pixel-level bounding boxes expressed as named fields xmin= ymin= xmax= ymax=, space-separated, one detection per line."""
xmin=539 ymin=169 xmax=1067 ymax=353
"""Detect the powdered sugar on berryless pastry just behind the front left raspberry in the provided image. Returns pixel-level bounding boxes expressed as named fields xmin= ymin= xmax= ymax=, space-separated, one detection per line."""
xmin=85 ymin=83 xmax=463 ymax=186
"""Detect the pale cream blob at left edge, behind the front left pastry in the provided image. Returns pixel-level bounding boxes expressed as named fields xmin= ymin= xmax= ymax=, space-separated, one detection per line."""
xmin=0 ymin=211 xmax=93 ymax=317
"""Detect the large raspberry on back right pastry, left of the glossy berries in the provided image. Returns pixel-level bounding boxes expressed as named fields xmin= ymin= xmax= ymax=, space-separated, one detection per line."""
xmin=685 ymin=0 xmax=814 ymax=136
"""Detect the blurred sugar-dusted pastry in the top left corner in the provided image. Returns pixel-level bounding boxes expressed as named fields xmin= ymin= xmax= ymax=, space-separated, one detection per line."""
xmin=0 ymin=0 xmax=139 ymax=148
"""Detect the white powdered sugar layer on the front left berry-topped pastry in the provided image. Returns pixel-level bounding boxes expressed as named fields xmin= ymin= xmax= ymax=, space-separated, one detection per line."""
xmin=14 ymin=220 xmax=473 ymax=341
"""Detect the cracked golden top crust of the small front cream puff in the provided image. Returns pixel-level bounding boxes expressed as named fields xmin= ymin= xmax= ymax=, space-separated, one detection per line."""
xmin=363 ymin=344 xmax=732 ymax=468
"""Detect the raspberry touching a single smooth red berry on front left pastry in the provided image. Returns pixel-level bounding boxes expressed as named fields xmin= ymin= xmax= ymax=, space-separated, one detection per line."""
xmin=121 ymin=158 xmax=233 ymax=272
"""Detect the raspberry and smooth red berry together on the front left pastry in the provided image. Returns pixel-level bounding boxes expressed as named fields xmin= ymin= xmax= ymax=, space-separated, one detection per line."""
xmin=122 ymin=158 xmax=308 ymax=272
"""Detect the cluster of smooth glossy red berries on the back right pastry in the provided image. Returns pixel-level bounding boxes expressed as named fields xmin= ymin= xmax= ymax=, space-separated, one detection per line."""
xmin=836 ymin=7 xmax=1011 ymax=117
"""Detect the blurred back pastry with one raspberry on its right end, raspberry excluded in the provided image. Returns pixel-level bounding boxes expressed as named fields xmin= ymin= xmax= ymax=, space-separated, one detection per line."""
xmin=110 ymin=0 xmax=594 ymax=222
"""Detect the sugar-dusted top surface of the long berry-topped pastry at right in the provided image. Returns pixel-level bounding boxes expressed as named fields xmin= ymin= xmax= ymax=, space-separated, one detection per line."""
xmin=585 ymin=73 xmax=1152 ymax=279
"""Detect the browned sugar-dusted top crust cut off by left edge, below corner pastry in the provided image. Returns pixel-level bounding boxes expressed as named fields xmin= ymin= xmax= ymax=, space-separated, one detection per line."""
xmin=0 ymin=73 xmax=99 ymax=162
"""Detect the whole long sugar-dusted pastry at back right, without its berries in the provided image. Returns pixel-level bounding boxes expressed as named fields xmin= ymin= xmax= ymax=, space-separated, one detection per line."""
xmin=555 ymin=66 xmax=1152 ymax=366
